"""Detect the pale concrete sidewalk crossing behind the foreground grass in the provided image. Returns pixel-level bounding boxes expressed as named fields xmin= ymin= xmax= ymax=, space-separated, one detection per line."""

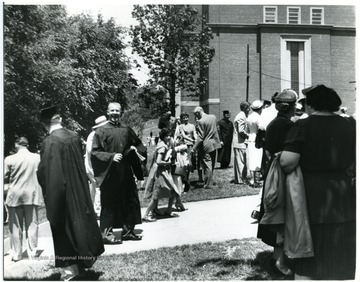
xmin=4 ymin=195 xmax=260 ymax=277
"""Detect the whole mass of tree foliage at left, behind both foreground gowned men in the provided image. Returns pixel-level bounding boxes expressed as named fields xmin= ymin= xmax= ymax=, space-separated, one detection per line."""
xmin=4 ymin=5 xmax=137 ymax=154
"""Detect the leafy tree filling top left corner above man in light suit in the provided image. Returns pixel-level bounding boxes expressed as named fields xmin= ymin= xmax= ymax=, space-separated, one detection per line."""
xmin=4 ymin=5 xmax=69 ymax=153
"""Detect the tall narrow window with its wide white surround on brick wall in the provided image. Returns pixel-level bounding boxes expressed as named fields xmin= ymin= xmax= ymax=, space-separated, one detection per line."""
xmin=281 ymin=35 xmax=311 ymax=96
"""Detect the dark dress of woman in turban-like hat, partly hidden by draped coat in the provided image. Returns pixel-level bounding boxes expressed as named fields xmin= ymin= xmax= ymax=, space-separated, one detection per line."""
xmin=257 ymin=113 xmax=294 ymax=247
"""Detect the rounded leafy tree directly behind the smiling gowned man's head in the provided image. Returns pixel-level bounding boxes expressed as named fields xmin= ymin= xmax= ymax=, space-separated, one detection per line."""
xmin=70 ymin=15 xmax=137 ymax=128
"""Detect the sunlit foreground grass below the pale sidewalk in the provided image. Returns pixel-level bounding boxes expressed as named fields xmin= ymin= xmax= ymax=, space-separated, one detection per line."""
xmin=9 ymin=238 xmax=293 ymax=281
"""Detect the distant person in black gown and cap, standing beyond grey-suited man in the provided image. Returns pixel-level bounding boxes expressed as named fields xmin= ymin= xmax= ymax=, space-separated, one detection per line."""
xmin=218 ymin=110 xmax=234 ymax=168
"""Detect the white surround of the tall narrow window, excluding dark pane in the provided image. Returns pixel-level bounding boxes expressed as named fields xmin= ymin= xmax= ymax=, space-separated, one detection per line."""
xmin=280 ymin=35 xmax=312 ymax=94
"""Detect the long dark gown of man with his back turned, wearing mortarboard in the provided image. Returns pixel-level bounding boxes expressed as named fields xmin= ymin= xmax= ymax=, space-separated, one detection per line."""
xmin=37 ymin=128 xmax=104 ymax=267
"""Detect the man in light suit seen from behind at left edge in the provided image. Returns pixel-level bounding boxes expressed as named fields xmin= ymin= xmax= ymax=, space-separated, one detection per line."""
xmin=4 ymin=137 xmax=43 ymax=261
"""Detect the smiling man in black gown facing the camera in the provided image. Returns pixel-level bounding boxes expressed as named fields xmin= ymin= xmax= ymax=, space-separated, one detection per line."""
xmin=91 ymin=102 xmax=146 ymax=244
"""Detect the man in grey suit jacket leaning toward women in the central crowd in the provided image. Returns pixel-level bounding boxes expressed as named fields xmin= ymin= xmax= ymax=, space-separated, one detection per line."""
xmin=192 ymin=107 xmax=221 ymax=189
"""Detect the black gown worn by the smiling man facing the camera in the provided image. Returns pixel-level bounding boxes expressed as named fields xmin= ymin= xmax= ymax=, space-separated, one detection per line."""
xmin=91 ymin=122 xmax=145 ymax=231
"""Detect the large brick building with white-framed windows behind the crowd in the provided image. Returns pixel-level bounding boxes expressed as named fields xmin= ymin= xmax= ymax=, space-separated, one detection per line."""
xmin=178 ymin=5 xmax=356 ymax=118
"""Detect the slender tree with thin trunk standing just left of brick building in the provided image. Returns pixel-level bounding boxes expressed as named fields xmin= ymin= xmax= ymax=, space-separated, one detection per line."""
xmin=131 ymin=5 xmax=214 ymax=114
